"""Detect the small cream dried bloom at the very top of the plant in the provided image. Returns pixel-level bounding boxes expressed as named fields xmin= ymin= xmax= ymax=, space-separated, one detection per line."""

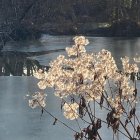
xmin=73 ymin=36 xmax=89 ymax=46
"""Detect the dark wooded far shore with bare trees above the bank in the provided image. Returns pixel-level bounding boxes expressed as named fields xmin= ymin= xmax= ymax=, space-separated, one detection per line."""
xmin=0 ymin=0 xmax=140 ymax=39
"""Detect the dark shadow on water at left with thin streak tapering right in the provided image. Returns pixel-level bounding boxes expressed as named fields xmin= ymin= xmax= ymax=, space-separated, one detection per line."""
xmin=0 ymin=49 xmax=64 ymax=76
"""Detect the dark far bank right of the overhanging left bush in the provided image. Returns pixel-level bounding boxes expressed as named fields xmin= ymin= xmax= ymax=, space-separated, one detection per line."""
xmin=43 ymin=20 xmax=140 ymax=37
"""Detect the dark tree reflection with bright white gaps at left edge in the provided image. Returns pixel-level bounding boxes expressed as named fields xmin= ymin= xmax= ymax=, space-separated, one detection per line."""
xmin=0 ymin=52 xmax=42 ymax=76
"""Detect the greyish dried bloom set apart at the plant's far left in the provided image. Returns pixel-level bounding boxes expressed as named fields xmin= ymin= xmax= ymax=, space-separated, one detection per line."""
xmin=28 ymin=92 xmax=46 ymax=109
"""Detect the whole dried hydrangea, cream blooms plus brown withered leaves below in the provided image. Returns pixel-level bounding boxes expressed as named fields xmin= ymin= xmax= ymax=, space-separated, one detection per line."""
xmin=29 ymin=36 xmax=139 ymax=140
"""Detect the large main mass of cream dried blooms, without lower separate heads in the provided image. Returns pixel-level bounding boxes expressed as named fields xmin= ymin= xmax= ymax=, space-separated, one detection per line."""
xmin=34 ymin=36 xmax=138 ymax=119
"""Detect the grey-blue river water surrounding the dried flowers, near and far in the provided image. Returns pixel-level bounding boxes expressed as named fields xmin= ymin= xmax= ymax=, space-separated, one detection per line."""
xmin=0 ymin=35 xmax=140 ymax=140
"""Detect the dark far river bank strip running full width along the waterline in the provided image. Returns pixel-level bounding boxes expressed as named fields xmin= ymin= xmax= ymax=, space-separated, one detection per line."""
xmin=0 ymin=20 xmax=140 ymax=48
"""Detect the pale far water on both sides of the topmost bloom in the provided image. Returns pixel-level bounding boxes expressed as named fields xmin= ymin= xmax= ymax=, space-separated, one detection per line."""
xmin=4 ymin=35 xmax=140 ymax=66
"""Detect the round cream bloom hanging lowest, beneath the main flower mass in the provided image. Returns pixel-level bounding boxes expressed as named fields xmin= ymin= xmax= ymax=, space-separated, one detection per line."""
xmin=63 ymin=103 xmax=79 ymax=120
